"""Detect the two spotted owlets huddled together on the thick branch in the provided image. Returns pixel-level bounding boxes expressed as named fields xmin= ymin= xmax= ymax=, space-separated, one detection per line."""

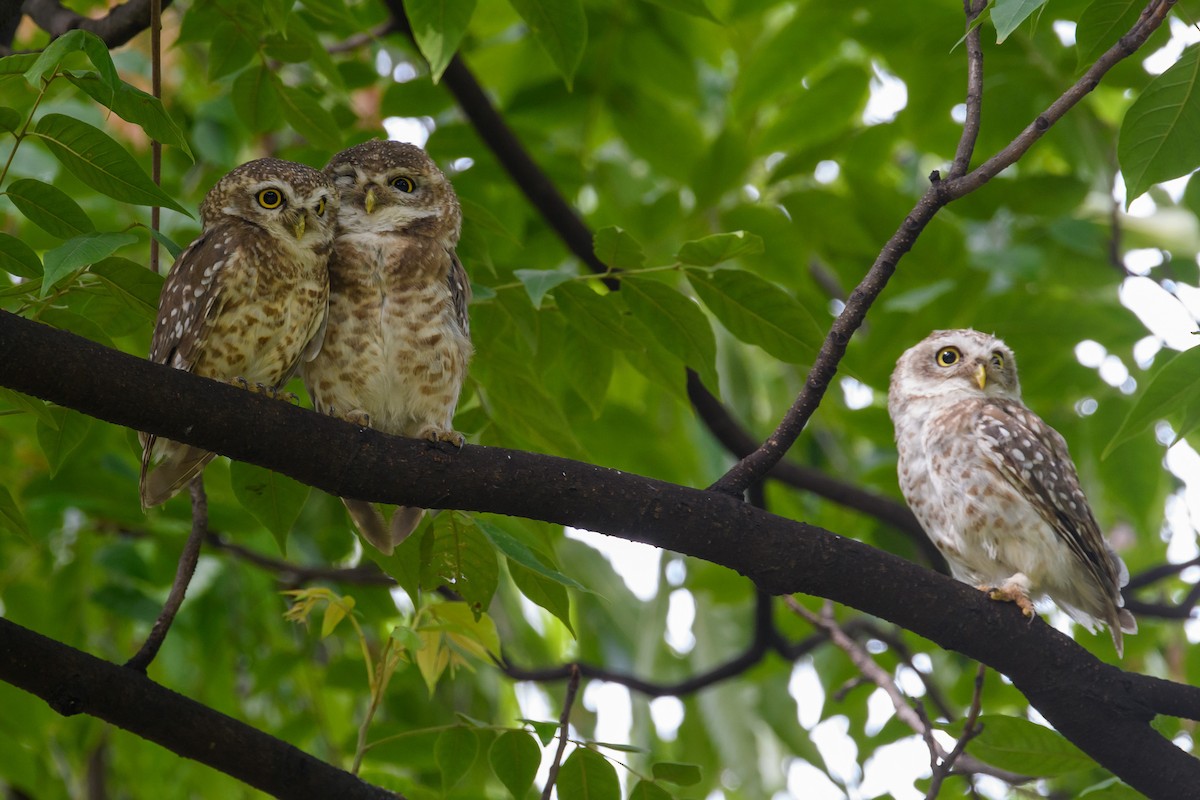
xmin=140 ymin=140 xmax=472 ymax=553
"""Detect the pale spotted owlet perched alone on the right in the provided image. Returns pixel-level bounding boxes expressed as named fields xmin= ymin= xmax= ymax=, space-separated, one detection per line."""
xmin=888 ymin=330 xmax=1138 ymax=655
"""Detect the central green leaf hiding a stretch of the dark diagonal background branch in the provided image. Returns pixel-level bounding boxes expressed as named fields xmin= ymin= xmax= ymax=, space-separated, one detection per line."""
xmin=620 ymin=277 xmax=720 ymax=390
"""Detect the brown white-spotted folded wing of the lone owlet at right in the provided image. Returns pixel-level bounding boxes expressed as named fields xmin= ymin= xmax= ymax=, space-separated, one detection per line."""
xmin=976 ymin=401 xmax=1123 ymax=595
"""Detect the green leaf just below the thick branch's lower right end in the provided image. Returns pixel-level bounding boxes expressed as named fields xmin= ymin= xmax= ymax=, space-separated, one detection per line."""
xmin=943 ymin=714 xmax=1096 ymax=777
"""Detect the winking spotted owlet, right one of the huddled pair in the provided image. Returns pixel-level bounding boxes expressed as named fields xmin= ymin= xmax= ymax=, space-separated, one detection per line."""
xmin=301 ymin=140 xmax=472 ymax=553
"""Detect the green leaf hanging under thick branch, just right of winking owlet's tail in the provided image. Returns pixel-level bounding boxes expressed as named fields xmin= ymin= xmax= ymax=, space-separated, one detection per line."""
xmin=421 ymin=512 xmax=500 ymax=619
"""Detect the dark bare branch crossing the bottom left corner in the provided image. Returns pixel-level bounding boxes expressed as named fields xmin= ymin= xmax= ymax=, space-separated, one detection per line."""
xmin=0 ymin=618 xmax=398 ymax=800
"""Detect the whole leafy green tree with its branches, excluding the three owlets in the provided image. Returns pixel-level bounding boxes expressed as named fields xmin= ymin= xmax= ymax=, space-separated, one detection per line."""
xmin=0 ymin=0 xmax=1200 ymax=800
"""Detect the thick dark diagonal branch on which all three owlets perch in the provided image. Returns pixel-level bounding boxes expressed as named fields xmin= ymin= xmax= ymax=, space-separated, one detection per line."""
xmin=0 ymin=312 xmax=1200 ymax=800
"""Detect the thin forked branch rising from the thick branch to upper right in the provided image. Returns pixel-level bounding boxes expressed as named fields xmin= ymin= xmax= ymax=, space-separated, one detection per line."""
xmin=712 ymin=0 xmax=1175 ymax=495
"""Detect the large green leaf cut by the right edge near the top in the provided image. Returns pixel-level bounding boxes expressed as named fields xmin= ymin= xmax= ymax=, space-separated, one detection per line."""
xmin=1117 ymin=46 xmax=1200 ymax=207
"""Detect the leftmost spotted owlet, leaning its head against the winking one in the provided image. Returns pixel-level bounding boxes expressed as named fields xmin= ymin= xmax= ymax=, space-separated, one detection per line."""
xmin=142 ymin=158 xmax=337 ymax=507
